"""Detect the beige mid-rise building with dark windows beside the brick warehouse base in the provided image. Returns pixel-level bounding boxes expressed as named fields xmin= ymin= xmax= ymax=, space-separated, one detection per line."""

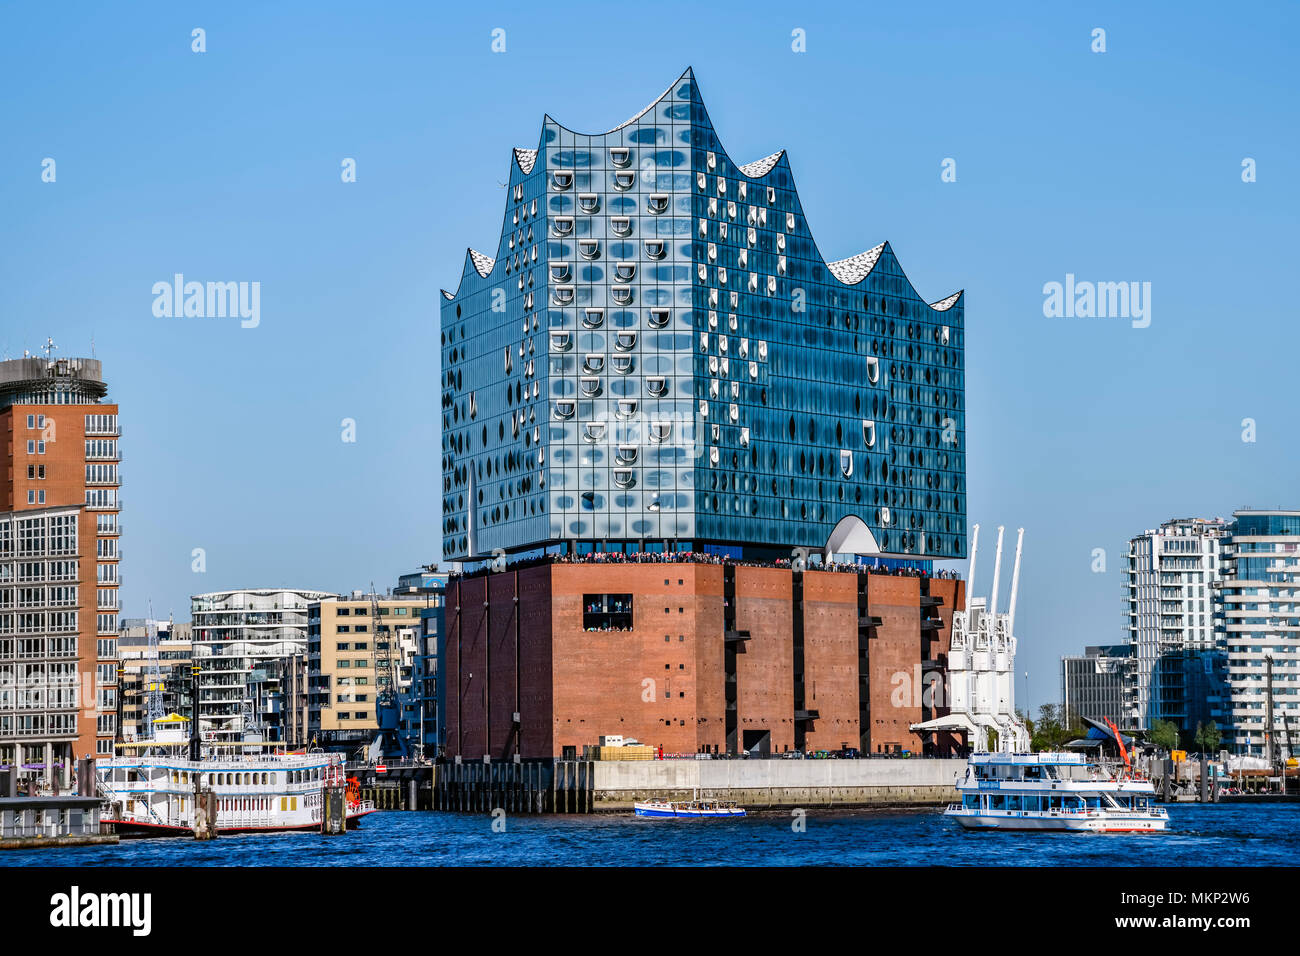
xmin=307 ymin=588 xmax=428 ymax=752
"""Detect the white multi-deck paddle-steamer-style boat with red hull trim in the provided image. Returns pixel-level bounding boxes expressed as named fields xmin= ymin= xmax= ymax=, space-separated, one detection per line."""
xmin=95 ymin=747 xmax=374 ymax=836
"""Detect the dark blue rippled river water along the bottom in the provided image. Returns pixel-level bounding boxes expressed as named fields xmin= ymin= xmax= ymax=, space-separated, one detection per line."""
xmin=0 ymin=804 xmax=1300 ymax=866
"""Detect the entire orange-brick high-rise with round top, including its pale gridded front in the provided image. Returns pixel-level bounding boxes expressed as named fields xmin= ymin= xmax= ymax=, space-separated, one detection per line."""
xmin=0 ymin=358 xmax=121 ymax=779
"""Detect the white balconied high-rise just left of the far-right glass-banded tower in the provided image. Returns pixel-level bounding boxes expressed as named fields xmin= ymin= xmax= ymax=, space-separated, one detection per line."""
xmin=1123 ymin=518 xmax=1226 ymax=731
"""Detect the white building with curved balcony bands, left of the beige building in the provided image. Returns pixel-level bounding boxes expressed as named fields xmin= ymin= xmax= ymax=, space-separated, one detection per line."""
xmin=190 ymin=588 xmax=332 ymax=743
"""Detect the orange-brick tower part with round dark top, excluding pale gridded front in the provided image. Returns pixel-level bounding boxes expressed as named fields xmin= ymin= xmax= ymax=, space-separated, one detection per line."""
xmin=0 ymin=351 xmax=121 ymax=756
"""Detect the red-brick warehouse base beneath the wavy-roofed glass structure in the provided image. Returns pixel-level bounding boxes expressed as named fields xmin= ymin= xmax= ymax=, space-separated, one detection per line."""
xmin=442 ymin=563 xmax=965 ymax=758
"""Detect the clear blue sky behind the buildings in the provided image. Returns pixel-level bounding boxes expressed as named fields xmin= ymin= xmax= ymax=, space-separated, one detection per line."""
xmin=0 ymin=0 xmax=1300 ymax=705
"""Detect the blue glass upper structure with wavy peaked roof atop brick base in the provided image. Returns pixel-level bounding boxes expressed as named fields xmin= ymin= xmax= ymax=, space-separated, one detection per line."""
xmin=441 ymin=70 xmax=966 ymax=561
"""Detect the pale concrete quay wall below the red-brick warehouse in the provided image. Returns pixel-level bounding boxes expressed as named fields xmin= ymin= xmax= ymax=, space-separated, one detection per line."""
xmin=592 ymin=758 xmax=966 ymax=810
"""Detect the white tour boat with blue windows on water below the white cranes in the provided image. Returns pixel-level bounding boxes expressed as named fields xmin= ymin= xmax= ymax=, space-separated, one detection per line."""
xmin=944 ymin=753 xmax=1169 ymax=834
